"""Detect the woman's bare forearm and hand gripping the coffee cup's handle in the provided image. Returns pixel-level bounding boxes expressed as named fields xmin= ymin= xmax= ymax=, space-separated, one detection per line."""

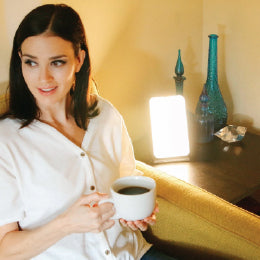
xmin=0 ymin=193 xmax=115 ymax=260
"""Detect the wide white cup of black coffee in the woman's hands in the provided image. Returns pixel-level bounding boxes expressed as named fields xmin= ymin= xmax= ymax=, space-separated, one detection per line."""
xmin=99 ymin=176 xmax=156 ymax=221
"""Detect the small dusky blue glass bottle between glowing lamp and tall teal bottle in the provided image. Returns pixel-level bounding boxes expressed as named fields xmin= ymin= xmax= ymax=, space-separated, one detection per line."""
xmin=195 ymin=84 xmax=214 ymax=143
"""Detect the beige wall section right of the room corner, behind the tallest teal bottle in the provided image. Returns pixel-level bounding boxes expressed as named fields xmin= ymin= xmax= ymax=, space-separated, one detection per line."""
xmin=203 ymin=0 xmax=260 ymax=136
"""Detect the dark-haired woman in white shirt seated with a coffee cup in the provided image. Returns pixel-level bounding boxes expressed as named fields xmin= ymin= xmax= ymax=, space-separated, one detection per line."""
xmin=0 ymin=5 xmax=175 ymax=260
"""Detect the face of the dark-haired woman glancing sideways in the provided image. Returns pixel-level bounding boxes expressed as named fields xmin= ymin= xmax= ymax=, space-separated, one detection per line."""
xmin=19 ymin=34 xmax=85 ymax=109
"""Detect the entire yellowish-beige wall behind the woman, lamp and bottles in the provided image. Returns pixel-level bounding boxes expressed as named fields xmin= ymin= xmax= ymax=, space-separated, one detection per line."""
xmin=0 ymin=0 xmax=260 ymax=162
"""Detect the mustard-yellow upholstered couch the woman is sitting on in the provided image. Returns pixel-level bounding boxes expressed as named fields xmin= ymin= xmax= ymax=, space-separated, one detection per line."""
xmin=0 ymin=92 xmax=260 ymax=260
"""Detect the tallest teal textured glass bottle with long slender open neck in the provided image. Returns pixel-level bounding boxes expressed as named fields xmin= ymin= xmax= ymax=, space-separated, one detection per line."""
xmin=196 ymin=34 xmax=227 ymax=132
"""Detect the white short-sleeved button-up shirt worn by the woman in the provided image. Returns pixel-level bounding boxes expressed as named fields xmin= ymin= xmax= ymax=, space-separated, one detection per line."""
xmin=0 ymin=97 xmax=150 ymax=260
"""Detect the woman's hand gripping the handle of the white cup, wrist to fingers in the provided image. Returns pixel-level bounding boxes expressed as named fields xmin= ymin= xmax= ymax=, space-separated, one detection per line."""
xmin=60 ymin=192 xmax=115 ymax=234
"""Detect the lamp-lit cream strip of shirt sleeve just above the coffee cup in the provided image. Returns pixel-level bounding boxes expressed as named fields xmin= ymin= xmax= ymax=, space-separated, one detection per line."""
xmin=120 ymin=120 xmax=140 ymax=177
